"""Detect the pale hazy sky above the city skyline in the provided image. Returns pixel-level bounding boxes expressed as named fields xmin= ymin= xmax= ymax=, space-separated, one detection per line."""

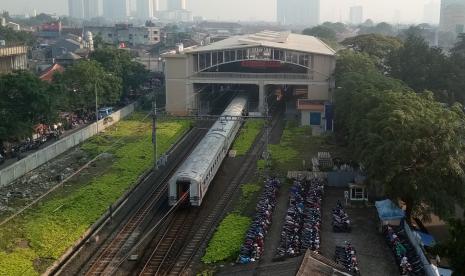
xmin=0 ymin=0 xmax=439 ymax=23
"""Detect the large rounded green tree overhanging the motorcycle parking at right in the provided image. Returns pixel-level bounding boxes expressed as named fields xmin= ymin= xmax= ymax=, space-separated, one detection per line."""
xmin=356 ymin=92 xmax=465 ymax=220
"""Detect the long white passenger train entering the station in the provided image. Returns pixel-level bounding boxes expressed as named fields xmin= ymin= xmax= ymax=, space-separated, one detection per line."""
xmin=168 ymin=96 xmax=247 ymax=206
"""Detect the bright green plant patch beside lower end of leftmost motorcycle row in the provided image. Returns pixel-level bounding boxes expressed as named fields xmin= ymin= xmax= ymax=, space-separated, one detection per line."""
xmin=202 ymin=213 xmax=252 ymax=264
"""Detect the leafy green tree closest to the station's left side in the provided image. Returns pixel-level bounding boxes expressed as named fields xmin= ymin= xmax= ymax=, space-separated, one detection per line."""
xmin=91 ymin=47 xmax=150 ymax=95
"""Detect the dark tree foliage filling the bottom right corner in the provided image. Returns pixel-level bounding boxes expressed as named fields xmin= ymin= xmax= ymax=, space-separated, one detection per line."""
xmin=438 ymin=219 xmax=465 ymax=276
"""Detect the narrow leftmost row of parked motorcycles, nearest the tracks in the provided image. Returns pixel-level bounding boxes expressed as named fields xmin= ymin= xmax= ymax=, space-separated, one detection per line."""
xmin=237 ymin=178 xmax=280 ymax=264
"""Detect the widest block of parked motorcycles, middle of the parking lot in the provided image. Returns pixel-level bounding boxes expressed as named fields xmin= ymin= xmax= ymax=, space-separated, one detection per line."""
xmin=277 ymin=178 xmax=324 ymax=257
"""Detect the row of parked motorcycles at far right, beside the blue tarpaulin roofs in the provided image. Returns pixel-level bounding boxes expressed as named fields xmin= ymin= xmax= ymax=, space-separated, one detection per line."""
xmin=383 ymin=225 xmax=426 ymax=276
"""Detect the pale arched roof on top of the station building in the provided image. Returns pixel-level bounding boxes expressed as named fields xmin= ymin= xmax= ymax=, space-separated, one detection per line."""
xmin=186 ymin=31 xmax=336 ymax=56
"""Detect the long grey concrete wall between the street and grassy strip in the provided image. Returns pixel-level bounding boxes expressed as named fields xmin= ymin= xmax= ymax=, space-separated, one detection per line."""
xmin=0 ymin=104 xmax=135 ymax=187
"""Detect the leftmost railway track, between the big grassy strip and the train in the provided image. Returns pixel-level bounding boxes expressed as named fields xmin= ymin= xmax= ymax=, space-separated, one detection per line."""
xmin=85 ymin=126 xmax=205 ymax=276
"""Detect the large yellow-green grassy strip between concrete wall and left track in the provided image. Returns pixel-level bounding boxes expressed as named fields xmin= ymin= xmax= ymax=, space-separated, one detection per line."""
xmin=0 ymin=114 xmax=190 ymax=275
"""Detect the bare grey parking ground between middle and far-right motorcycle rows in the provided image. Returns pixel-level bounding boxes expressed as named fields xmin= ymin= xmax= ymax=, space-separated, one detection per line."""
xmin=321 ymin=187 xmax=399 ymax=276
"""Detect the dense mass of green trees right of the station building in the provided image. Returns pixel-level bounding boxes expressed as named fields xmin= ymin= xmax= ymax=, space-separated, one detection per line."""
xmin=335 ymin=30 xmax=465 ymax=223
